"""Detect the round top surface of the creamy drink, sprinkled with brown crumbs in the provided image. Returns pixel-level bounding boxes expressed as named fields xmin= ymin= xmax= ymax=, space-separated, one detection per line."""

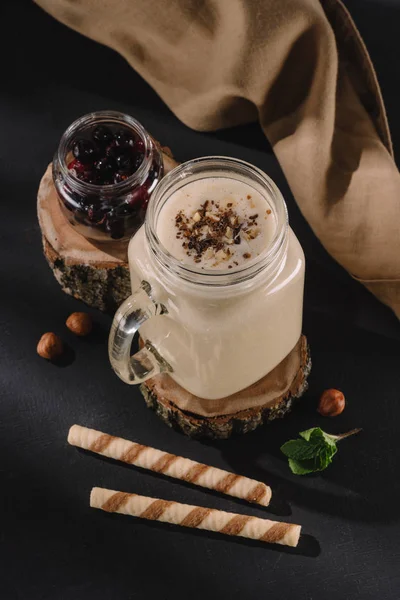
xmin=157 ymin=177 xmax=276 ymax=270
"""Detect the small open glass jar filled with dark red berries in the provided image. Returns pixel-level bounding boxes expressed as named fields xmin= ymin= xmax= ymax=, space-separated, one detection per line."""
xmin=53 ymin=111 xmax=163 ymax=242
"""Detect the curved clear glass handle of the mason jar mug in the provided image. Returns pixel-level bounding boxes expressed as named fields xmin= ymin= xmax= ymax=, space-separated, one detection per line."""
xmin=108 ymin=281 xmax=172 ymax=385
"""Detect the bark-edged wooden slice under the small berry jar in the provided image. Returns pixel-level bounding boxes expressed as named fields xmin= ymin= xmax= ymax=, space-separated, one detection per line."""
xmin=37 ymin=147 xmax=178 ymax=312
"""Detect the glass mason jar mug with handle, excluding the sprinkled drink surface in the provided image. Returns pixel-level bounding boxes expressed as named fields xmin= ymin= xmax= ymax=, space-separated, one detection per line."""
xmin=109 ymin=156 xmax=305 ymax=399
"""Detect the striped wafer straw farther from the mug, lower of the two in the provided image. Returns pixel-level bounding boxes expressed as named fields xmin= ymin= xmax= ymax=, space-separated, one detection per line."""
xmin=90 ymin=488 xmax=301 ymax=546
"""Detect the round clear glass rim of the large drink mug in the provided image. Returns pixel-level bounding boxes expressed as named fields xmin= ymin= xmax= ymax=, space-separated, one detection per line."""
xmin=145 ymin=156 xmax=289 ymax=286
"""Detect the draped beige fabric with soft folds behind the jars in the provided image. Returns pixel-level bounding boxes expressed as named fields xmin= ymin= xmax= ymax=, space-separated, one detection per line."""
xmin=38 ymin=0 xmax=400 ymax=316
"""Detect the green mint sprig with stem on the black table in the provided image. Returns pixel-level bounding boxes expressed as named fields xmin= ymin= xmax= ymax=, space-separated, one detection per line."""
xmin=281 ymin=427 xmax=360 ymax=475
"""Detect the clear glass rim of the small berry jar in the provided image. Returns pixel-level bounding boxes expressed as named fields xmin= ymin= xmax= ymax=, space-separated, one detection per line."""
xmin=55 ymin=110 xmax=153 ymax=195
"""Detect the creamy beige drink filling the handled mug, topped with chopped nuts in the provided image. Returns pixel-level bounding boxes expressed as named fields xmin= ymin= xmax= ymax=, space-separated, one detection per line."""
xmin=123 ymin=158 xmax=304 ymax=399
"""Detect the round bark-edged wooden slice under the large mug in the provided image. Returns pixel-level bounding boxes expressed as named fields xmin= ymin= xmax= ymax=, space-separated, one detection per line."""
xmin=140 ymin=335 xmax=311 ymax=439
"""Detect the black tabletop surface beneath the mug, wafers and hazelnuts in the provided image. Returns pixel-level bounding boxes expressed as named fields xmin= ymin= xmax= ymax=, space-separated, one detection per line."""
xmin=0 ymin=0 xmax=400 ymax=600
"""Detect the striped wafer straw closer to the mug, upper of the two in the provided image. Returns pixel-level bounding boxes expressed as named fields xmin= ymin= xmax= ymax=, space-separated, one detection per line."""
xmin=68 ymin=425 xmax=272 ymax=506
